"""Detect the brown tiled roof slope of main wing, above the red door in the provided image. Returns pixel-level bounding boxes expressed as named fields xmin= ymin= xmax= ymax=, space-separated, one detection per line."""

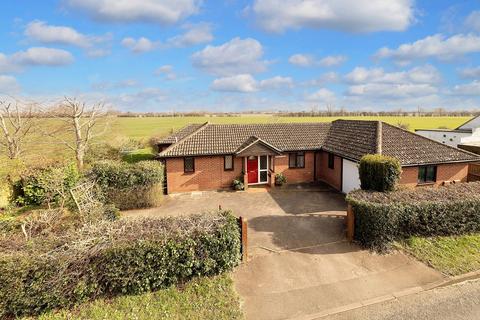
xmin=160 ymin=123 xmax=331 ymax=157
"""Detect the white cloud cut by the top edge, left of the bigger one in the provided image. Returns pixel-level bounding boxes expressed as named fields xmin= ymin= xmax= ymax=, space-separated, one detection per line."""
xmin=67 ymin=0 xmax=202 ymax=25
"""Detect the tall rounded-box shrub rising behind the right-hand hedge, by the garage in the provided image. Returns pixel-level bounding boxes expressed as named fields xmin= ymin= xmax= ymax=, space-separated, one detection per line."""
xmin=358 ymin=154 xmax=402 ymax=192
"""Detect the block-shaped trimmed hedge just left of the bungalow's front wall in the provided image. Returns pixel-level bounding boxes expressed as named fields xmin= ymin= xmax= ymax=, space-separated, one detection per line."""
xmin=88 ymin=161 xmax=163 ymax=210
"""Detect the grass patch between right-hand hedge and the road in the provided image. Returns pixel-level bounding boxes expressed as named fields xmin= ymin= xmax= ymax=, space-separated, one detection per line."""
xmin=402 ymin=234 xmax=480 ymax=276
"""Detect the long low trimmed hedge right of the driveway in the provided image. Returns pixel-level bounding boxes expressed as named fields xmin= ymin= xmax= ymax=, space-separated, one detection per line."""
xmin=347 ymin=182 xmax=480 ymax=251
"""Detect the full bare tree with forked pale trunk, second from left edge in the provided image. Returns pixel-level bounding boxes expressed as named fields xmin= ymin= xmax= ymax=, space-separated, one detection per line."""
xmin=47 ymin=97 xmax=109 ymax=170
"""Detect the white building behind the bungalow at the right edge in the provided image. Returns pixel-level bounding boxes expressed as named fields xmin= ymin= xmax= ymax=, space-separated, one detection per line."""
xmin=415 ymin=116 xmax=480 ymax=153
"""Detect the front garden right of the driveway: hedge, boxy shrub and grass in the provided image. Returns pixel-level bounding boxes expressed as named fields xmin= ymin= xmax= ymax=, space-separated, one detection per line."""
xmin=347 ymin=155 xmax=480 ymax=275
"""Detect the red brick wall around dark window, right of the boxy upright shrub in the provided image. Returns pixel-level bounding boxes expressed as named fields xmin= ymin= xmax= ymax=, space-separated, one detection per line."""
xmin=400 ymin=163 xmax=468 ymax=187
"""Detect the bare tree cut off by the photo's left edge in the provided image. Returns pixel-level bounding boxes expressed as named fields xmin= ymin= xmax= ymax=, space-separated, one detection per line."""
xmin=0 ymin=98 xmax=35 ymax=159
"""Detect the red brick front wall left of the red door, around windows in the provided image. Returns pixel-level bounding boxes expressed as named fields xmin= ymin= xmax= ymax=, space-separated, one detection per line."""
xmin=166 ymin=156 xmax=243 ymax=193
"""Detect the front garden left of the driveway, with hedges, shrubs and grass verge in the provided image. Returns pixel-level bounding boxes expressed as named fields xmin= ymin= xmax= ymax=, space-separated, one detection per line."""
xmin=0 ymin=149 xmax=241 ymax=319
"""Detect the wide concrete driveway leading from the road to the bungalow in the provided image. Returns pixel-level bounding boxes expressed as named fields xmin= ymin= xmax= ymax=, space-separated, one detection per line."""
xmin=126 ymin=187 xmax=443 ymax=319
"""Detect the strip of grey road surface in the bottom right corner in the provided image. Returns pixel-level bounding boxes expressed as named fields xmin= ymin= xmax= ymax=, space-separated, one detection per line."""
xmin=316 ymin=280 xmax=480 ymax=320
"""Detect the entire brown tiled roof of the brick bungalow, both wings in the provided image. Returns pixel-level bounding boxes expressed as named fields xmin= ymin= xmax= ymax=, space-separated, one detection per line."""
xmin=159 ymin=120 xmax=480 ymax=165
